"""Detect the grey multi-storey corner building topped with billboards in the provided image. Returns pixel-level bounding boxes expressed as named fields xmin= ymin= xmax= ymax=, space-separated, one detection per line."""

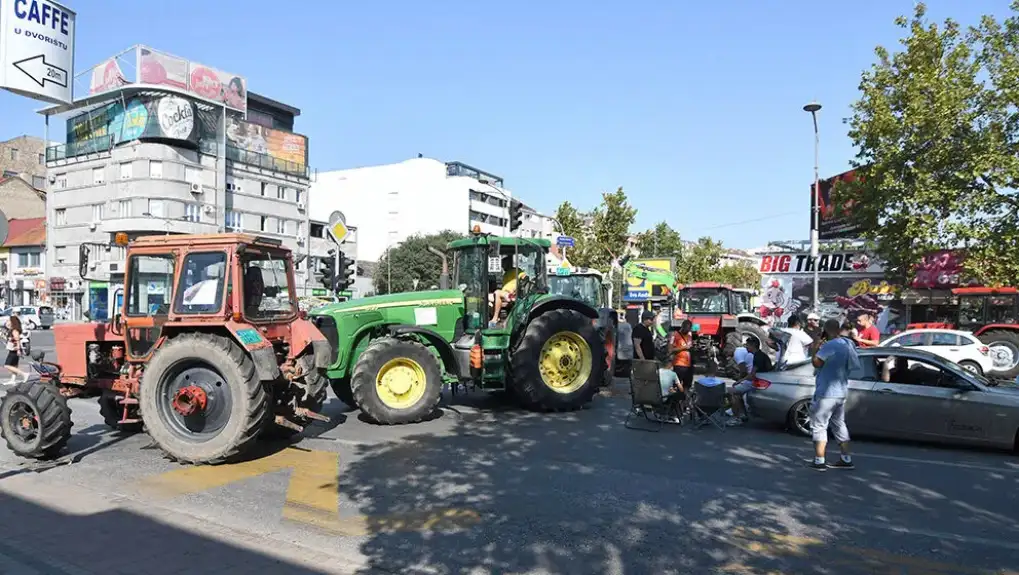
xmin=42 ymin=46 xmax=326 ymax=319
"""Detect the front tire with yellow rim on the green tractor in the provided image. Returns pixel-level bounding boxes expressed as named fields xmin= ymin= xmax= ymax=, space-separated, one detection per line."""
xmin=351 ymin=337 xmax=442 ymax=425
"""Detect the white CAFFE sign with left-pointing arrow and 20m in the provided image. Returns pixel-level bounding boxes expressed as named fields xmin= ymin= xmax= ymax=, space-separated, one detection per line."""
xmin=0 ymin=0 xmax=75 ymax=104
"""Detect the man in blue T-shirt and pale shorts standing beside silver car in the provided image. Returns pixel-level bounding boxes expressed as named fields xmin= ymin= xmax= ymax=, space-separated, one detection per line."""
xmin=810 ymin=319 xmax=860 ymax=471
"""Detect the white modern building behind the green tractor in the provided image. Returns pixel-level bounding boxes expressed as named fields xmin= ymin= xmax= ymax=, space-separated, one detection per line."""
xmin=311 ymin=157 xmax=547 ymax=261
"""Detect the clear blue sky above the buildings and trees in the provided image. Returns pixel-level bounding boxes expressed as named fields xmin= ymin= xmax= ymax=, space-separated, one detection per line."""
xmin=0 ymin=0 xmax=1008 ymax=248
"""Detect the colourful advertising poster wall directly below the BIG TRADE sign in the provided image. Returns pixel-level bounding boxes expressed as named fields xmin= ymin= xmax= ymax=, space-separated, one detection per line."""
xmin=757 ymin=274 xmax=905 ymax=333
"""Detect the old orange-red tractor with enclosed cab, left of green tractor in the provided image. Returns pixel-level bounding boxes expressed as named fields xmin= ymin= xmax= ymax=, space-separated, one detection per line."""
xmin=0 ymin=233 xmax=332 ymax=464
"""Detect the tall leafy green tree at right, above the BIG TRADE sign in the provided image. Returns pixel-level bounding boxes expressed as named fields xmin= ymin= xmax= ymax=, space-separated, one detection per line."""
xmin=833 ymin=2 xmax=1019 ymax=284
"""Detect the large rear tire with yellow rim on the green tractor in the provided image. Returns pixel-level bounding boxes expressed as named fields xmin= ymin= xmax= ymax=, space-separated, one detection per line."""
xmin=510 ymin=309 xmax=605 ymax=411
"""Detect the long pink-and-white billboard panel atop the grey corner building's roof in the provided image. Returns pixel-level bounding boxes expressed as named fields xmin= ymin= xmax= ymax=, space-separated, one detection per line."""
xmin=138 ymin=46 xmax=248 ymax=112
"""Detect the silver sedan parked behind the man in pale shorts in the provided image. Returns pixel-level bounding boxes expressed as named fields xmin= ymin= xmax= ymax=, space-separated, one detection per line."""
xmin=747 ymin=348 xmax=1019 ymax=449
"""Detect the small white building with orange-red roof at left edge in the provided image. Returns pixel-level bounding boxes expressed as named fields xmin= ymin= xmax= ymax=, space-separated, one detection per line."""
xmin=0 ymin=217 xmax=47 ymax=307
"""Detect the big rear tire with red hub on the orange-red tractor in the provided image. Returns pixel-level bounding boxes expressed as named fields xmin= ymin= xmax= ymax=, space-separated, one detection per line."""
xmin=140 ymin=333 xmax=270 ymax=464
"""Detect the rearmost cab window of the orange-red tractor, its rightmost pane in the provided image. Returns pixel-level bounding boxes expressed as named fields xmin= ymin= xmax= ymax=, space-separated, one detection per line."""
xmin=240 ymin=254 xmax=297 ymax=321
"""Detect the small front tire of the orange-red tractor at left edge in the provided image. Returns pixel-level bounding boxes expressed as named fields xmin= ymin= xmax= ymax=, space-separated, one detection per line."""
xmin=0 ymin=379 xmax=73 ymax=459
